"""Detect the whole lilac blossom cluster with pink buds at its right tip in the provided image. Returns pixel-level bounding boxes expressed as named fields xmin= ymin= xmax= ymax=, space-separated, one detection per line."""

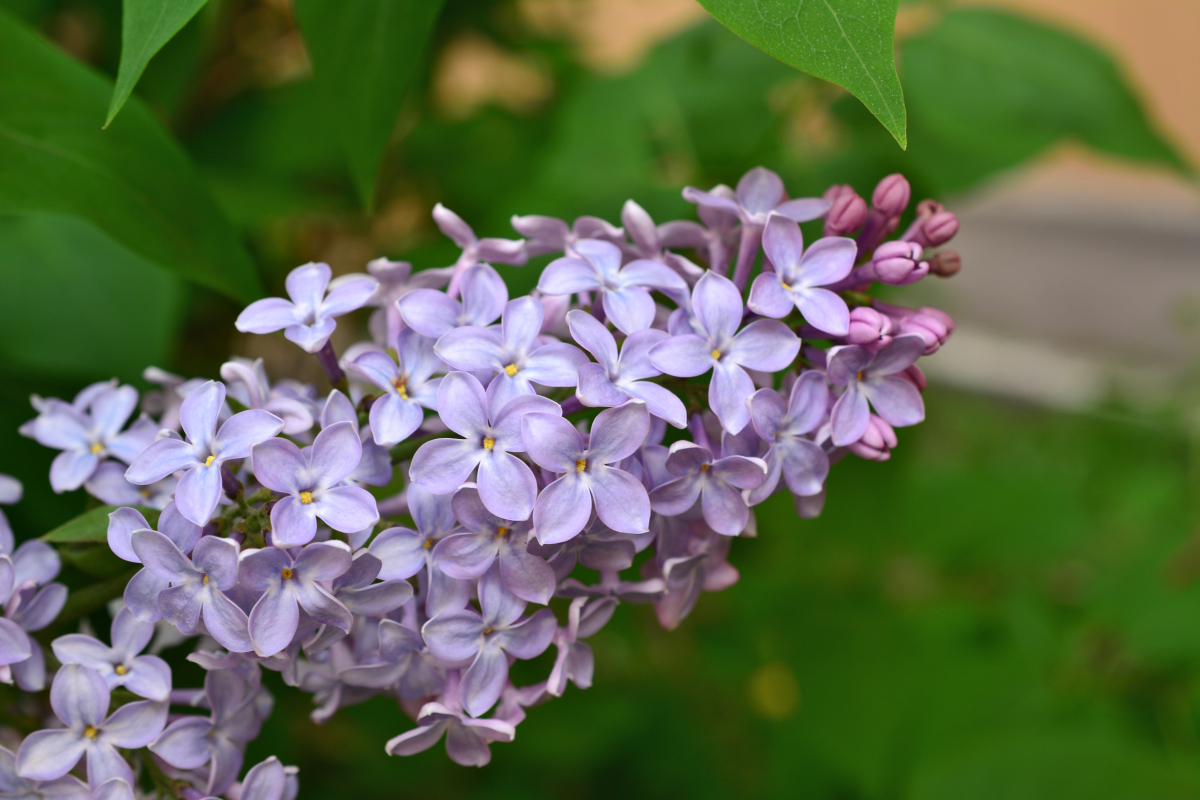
xmin=0 ymin=168 xmax=959 ymax=786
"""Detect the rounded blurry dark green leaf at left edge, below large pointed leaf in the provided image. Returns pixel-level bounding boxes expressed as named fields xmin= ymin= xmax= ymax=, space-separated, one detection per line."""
xmin=0 ymin=215 xmax=184 ymax=379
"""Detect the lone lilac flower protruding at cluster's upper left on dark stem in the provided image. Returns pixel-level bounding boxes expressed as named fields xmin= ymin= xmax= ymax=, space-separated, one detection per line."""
xmin=234 ymin=261 xmax=379 ymax=353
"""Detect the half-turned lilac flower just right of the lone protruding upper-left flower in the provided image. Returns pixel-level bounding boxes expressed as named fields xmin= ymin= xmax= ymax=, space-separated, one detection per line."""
xmin=388 ymin=264 xmax=509 ymax=342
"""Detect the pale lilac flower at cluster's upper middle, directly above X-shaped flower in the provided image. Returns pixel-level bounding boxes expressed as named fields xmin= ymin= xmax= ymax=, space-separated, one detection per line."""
xmin=538 ymin=239 xmax=688 ymax=333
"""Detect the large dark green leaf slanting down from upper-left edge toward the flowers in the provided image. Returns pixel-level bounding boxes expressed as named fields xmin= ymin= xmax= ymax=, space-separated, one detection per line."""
xmin=0 ymin=12 xmax=262 ymax=300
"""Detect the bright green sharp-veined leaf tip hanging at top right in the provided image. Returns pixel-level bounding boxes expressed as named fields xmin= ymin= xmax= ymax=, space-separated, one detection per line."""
xmin=700 ymin=0 xmax=908 ymax=149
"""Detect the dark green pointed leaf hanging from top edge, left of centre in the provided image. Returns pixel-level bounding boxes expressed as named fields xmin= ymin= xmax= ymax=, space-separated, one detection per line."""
xmin=295 ymin=0 xmax=443 ymax=206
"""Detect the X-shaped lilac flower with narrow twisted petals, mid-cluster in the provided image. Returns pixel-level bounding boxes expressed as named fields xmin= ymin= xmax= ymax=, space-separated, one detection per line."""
xmin=566 ymin=309 xmax=688 ymax=428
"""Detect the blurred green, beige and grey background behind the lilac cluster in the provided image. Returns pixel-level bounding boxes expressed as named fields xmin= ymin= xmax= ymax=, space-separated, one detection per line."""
xmin=0 ymin=0 xmax=1200 ymax=800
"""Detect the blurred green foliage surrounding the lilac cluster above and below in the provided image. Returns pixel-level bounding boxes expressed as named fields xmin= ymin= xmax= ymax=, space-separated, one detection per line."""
xmin=0 ymin=0 xmax=1200 ymax=800
